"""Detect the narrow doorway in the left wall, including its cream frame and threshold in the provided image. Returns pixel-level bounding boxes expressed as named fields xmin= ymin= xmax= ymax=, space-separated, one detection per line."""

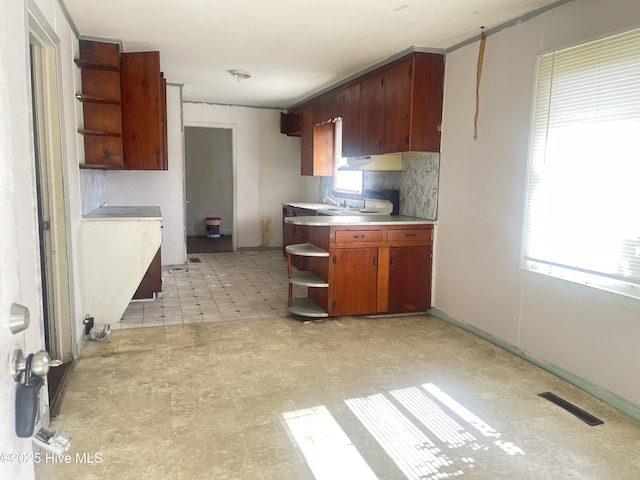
xmin=29 ymin=17 xmax=75 ymax=416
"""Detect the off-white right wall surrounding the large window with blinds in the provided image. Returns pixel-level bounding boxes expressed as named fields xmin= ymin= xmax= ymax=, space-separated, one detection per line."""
xmin=433 ymin=0 xmax=640 ymax=405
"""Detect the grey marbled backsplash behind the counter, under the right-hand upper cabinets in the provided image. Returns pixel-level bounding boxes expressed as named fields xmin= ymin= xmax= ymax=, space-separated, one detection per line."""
xmin=319 ymin=152 xmax=440 ymax=220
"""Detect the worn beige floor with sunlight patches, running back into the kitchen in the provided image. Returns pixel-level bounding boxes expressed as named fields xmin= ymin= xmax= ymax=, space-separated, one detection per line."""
xmin=36 ymin=252 xmax=640 ymax=480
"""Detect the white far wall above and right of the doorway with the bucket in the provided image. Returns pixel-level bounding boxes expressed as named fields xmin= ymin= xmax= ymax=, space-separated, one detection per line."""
xmin=183 ymin=103 xmax=306 ymax=248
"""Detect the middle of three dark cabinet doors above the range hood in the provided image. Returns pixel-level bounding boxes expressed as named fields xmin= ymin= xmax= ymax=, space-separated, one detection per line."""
xmin=360 ymin=74 xmax=384 ymax=155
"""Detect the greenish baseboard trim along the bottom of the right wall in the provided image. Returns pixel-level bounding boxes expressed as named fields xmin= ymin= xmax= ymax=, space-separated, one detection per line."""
xmin=427 ymin=308 xmax=640 ymax=421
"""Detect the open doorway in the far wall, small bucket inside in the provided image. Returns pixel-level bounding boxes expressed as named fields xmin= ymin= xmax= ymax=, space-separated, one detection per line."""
xmin=185 ymin=126 xmax=234 ymax=254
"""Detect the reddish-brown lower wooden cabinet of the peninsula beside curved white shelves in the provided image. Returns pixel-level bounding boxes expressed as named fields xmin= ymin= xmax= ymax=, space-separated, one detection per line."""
xmin=285 ymin=222 xmax=433 ymax=316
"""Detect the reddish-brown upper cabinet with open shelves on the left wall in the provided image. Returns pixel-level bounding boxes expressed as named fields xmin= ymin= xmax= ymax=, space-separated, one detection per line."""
xmin=76 ymin=40 xmax=168 ymax=170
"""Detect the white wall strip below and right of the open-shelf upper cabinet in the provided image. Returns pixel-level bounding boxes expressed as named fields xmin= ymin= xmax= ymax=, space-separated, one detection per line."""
xmin=106 ymin=85 xmax=187 ymax=265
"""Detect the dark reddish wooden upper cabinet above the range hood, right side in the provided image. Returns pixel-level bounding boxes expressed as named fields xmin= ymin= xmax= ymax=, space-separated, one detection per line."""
xmin=342 ymin=53 xmax=444 ymax=156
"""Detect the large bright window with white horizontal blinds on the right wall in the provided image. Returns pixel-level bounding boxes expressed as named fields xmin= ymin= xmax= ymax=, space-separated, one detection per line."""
xmin=523 ymin=30 xmax=640 ymax=298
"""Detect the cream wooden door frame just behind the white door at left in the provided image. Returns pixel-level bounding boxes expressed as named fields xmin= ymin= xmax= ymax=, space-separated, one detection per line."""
xmin=28 ymin=6 xmax=78 ymax=362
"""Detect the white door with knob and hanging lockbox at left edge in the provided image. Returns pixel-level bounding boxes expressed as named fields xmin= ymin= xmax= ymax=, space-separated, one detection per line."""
xmin=0 ymin=16 xmax=44 ymax=479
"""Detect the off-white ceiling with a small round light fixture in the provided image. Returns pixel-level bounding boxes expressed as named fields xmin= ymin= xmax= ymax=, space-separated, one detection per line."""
xmin=63 ymin=0 xmax=563 ymax=108
